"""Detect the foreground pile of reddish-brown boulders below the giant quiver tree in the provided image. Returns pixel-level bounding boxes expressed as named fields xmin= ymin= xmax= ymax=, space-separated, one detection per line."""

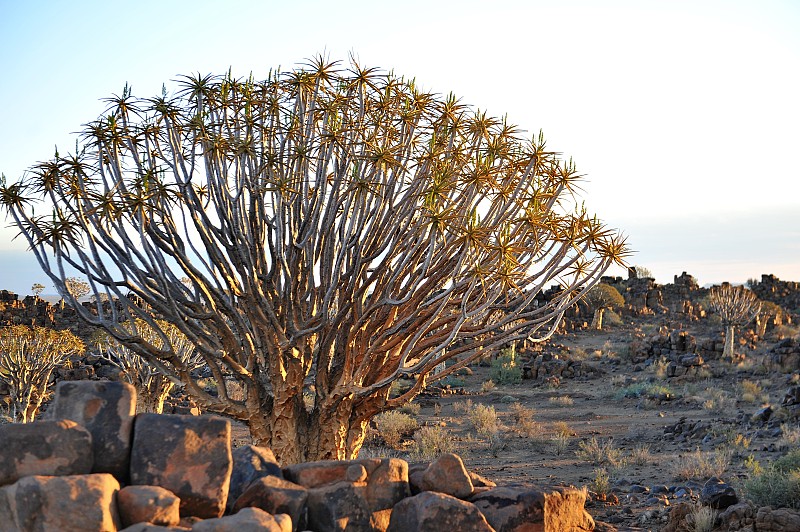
xmin=0 ymin=381 xmax=595 ymax=532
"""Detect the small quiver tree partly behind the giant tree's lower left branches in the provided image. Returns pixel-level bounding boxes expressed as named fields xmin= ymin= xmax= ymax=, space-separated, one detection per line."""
xmin=96 ymin=320 xmax=203 ymax=414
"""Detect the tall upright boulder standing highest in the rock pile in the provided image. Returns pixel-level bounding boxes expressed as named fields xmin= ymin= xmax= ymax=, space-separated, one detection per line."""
xmin=48 ymin=381 xmax=136 ymax=482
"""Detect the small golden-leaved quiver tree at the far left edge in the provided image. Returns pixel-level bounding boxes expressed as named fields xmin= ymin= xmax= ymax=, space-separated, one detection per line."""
xmin=0 ymin=325 xmax=84 ymax=423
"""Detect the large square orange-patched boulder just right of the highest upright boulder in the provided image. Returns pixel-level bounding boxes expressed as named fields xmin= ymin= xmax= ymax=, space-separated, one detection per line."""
xmin=130 ymin=414 xmax=233 ymax=518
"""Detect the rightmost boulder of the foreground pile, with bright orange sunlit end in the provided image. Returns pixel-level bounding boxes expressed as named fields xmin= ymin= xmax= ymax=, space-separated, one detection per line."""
xmin=469 ymin=485 xmax=594 ymax=532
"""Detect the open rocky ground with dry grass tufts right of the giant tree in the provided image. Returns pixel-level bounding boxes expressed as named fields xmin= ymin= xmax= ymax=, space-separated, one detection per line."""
xmin=352 ymin=318 xmax=800 ymax=530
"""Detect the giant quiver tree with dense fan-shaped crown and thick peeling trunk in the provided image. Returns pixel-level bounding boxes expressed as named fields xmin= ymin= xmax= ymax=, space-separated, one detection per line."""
xmin=0 ymin=58 xmax=626 ymax=462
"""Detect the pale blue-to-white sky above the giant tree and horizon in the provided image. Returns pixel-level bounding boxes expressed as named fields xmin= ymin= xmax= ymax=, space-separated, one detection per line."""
xmin=0 ymin=0 xmax=800 ymax=294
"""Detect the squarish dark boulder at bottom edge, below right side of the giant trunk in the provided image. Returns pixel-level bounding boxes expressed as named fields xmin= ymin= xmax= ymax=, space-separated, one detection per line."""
xmin=307 ymin=480 xmax=376 ymax=532
